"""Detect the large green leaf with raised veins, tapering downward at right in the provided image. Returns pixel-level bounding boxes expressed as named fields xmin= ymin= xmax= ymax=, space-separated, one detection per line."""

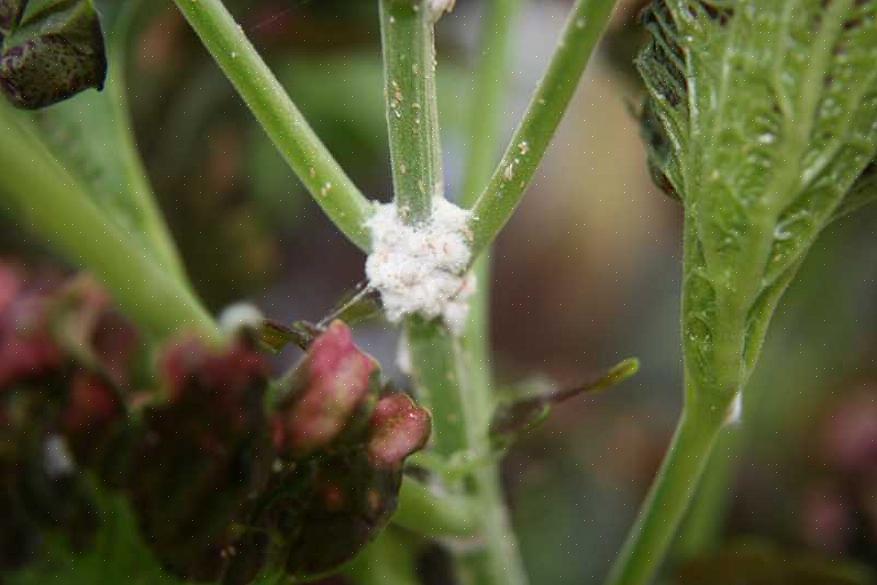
xmin=638 ymin=0 xmax=877 ymax=407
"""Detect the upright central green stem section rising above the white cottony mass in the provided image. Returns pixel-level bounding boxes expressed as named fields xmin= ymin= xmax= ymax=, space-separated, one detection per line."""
xmin=380 ymin=0 xmax=444 ymax=224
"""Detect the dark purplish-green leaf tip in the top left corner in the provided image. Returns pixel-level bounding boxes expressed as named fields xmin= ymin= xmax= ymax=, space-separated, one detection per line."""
xmin=0 ymin=0 xmax=107 ymax=109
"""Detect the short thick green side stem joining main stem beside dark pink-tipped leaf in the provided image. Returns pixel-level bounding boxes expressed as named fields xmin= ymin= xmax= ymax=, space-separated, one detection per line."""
xmin=393 ymin=478 xmax=478 ymax=537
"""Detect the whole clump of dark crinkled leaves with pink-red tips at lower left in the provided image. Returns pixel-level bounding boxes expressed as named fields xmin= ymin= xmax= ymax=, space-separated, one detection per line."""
xmin=0 ymin=264 xmax=430 ymax=585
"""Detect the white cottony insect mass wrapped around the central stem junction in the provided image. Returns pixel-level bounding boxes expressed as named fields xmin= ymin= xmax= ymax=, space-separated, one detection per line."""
xmin=365 ymin=197 xmax=475 ymax=335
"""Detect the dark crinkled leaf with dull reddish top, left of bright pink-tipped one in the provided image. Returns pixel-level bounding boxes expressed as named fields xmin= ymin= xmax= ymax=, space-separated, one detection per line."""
xmin=125 ymin=340 xmax=271 ymax=579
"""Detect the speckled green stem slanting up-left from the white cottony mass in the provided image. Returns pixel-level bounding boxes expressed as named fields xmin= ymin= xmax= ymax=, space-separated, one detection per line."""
xmin=175 ymin=0 xmax=371 ymax=250
